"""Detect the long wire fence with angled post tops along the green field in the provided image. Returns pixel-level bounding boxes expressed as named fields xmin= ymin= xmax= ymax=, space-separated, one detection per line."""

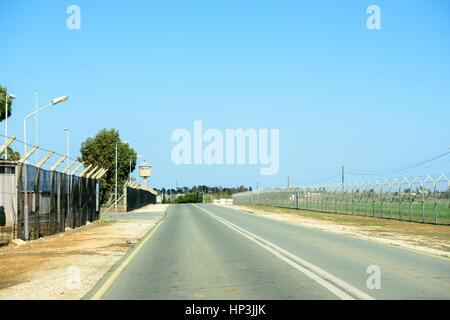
xmin=233 ymin=175 xmax=450 ymax=225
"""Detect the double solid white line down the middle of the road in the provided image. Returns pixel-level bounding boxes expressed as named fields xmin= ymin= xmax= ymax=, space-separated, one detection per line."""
xmin=193 ymin=204 xmax=374 ymax=300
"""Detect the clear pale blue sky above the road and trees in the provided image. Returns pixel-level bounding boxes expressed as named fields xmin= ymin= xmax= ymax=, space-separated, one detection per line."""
xmin=0 ymin=0 xmax=450 ymax=187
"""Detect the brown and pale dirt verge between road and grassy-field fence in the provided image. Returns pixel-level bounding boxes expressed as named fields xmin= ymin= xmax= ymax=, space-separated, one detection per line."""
xmin=217 ymin=204 xmax=450 ymax=259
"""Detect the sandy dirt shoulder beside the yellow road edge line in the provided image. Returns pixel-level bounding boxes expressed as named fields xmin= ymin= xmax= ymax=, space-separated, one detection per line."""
xmin=0 ymin=205 xmax=167 ymax=300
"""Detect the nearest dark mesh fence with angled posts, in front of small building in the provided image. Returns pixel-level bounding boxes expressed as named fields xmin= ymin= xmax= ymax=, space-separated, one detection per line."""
xmin=0 ymin=161 xmax=99 ymax=243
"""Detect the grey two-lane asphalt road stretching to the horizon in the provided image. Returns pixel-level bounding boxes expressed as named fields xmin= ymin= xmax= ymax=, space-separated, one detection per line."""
xmin=87 ymin=204 xmax=450 ymax=300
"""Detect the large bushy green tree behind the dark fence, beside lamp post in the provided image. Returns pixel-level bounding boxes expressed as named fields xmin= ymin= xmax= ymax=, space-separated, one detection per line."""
xmin=80 ymin=129 xmax=137 ymax=204
